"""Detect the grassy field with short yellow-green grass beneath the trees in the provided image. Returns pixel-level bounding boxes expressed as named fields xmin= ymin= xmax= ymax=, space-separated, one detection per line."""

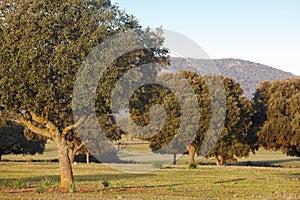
xmin=0 ymin=143 xmax=300 ymax=199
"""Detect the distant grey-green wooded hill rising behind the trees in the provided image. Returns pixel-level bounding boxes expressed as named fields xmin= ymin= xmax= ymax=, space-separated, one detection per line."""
xmin=168 ymin=57 xmax=295 ymax=99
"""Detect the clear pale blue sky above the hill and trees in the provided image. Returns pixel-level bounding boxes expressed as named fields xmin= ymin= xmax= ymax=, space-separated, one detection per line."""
xmin=112 ymin=0 xmax=300 ymax=75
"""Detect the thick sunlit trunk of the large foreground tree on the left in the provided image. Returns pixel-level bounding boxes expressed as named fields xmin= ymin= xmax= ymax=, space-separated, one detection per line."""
xmin=55 ymin=138 xmax=74 ymax=188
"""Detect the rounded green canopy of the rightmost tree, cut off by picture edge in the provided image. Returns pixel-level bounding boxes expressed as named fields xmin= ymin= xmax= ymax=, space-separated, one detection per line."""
xmin=252 ymin=78 xmax=300 ymax=156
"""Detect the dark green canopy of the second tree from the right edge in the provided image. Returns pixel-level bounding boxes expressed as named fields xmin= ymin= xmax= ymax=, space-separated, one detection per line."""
xmin=208 ymin=78 xmax=255 ymax=165
